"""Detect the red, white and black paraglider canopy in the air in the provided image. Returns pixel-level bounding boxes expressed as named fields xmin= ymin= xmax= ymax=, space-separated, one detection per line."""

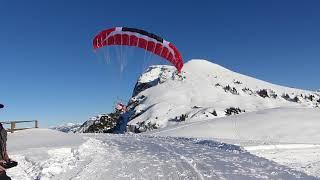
xmin=93 ymin=27 xmax=183 ymax=72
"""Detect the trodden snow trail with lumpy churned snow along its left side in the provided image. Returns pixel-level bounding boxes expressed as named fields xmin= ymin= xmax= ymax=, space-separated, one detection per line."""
xmin=8 ymin=134 xmax=315 ymax=180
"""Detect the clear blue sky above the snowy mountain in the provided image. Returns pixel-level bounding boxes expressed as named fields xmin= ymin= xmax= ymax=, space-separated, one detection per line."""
xmin=0 ymin=0 xmax=320 ymax=126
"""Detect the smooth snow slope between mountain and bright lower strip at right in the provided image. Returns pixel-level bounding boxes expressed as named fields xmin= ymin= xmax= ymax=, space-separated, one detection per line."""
xmin=151 ymin=108 xmax=320 ymax=145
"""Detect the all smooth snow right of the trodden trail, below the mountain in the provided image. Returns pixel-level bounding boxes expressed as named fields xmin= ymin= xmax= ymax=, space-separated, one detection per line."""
xmin=150 ymin=107 xmax=320 ymax=177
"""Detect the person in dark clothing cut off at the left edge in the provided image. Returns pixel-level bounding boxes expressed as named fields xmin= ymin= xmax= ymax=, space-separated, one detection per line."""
xmin=0 ymin=104 xmax=11 ymax=180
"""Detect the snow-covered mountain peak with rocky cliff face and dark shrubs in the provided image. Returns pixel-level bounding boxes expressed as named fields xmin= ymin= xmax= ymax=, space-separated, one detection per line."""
xmin=128 ymin=60 xmax=320 ymax=132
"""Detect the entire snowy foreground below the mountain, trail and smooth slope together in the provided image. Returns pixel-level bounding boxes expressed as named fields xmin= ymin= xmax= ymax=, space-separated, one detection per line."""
xmin=8 ymin=107 xmax=320 ymax=180
